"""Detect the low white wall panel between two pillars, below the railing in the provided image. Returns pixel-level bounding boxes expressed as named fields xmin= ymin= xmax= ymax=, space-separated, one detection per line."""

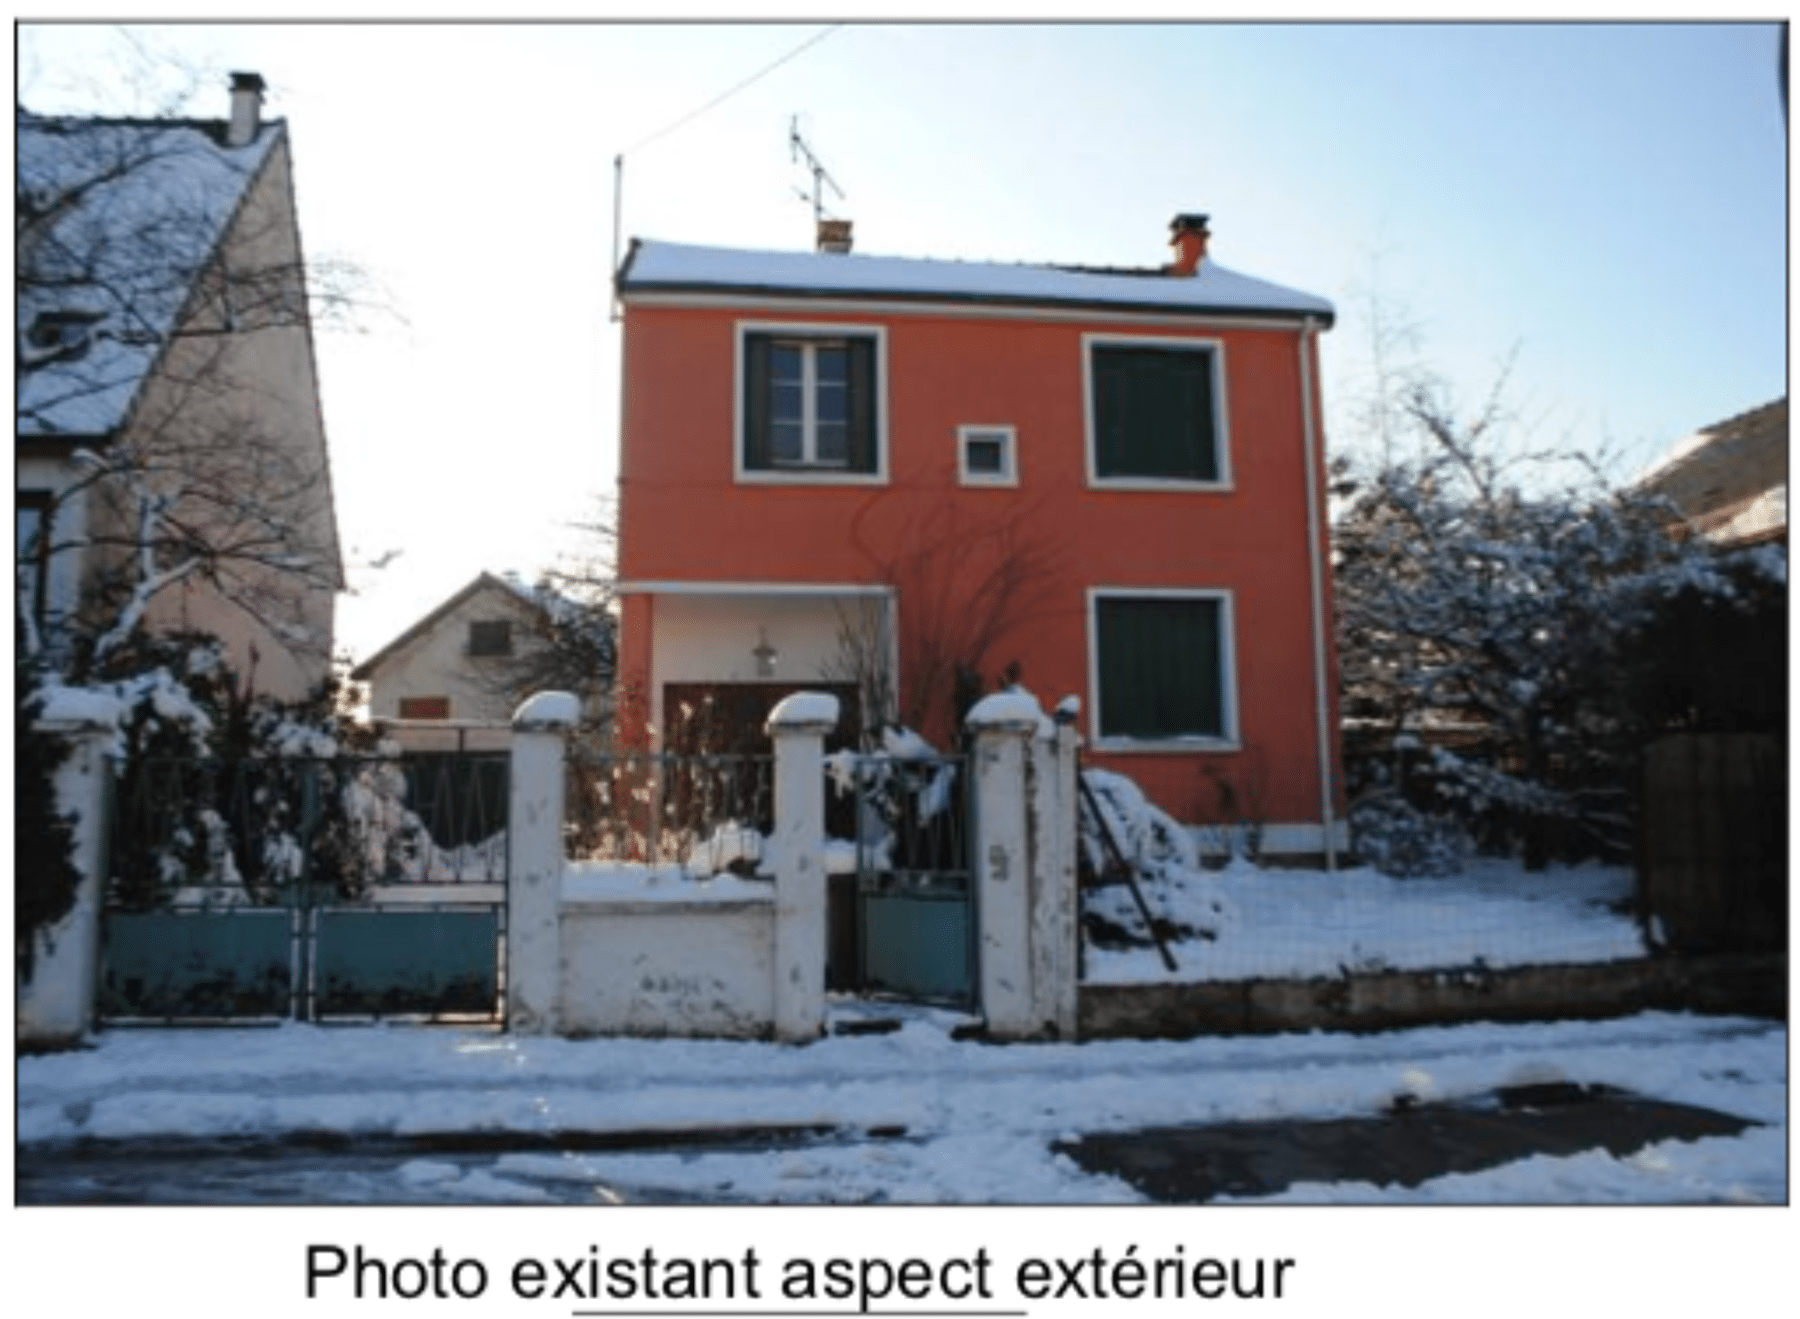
xmin=558 ymin=885 xmax=776 ymax=1038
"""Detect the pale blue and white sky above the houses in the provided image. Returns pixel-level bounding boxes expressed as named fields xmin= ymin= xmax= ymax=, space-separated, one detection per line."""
xmin=16 ymin=7 xmax=1787 ymax=659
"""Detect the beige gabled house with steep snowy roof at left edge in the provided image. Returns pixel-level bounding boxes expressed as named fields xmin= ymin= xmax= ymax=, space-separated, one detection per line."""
xmin=14 ymin=74 xmax=342 ymax=698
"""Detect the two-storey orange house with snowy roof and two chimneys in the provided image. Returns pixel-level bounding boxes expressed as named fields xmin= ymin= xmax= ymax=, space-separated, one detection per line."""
xmin=617 ymin=216 xmax=1343 ymax=853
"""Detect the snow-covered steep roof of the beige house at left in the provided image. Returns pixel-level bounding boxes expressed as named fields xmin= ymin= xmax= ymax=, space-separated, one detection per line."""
xmin=14 ymin=110 xmax=284 ymax=437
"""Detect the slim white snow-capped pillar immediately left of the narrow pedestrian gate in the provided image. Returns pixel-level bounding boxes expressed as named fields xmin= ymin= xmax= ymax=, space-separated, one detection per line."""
xmin=769 ymin=691 xmax=837 ymax=1042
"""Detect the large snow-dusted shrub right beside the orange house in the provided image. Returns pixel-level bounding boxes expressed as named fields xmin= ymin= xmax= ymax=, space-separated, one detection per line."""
xmin=1332 ymin=385 xmax=1764 ymax=869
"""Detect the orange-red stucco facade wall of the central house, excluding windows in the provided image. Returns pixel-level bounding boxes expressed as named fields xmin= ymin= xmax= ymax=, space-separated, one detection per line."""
xmin=619 ymin=241 xmax=1341 ymax=838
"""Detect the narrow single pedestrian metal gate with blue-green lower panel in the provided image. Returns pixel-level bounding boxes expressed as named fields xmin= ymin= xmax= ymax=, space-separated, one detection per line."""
xmin=838 ymin=756 xmax=977 ymax=1006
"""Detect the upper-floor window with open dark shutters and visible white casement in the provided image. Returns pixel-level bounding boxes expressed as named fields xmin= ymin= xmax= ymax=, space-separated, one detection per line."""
xmin=738 ymin=326 xmax=886 ymax=480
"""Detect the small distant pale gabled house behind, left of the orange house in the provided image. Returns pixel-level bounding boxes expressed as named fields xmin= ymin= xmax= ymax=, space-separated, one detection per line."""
xmin=351 ymin=572 xmax=599 ymax=727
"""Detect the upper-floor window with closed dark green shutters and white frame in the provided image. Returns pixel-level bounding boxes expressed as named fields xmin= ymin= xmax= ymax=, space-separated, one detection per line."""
xmin=1084 ymin=335 xmax=1231 ymax=489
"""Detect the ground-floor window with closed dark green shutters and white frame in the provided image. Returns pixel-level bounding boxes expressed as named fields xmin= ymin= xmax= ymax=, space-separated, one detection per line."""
xmin=1089 ymin=590 xmax=1237 ymax=747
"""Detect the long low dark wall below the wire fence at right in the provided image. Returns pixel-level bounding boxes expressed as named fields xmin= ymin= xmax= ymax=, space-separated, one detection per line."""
xmin=1080 ymin=954 xmax=1787 ymax=1040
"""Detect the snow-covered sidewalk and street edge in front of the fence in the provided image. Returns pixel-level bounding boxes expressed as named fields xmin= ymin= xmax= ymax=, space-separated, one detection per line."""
xmin=18 ymin=1013 xmax=1787 ymax=1204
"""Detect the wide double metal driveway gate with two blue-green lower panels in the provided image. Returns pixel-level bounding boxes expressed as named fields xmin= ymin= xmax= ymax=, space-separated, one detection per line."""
xmin=99 ymin=752 xmax=508 ymax=1024
